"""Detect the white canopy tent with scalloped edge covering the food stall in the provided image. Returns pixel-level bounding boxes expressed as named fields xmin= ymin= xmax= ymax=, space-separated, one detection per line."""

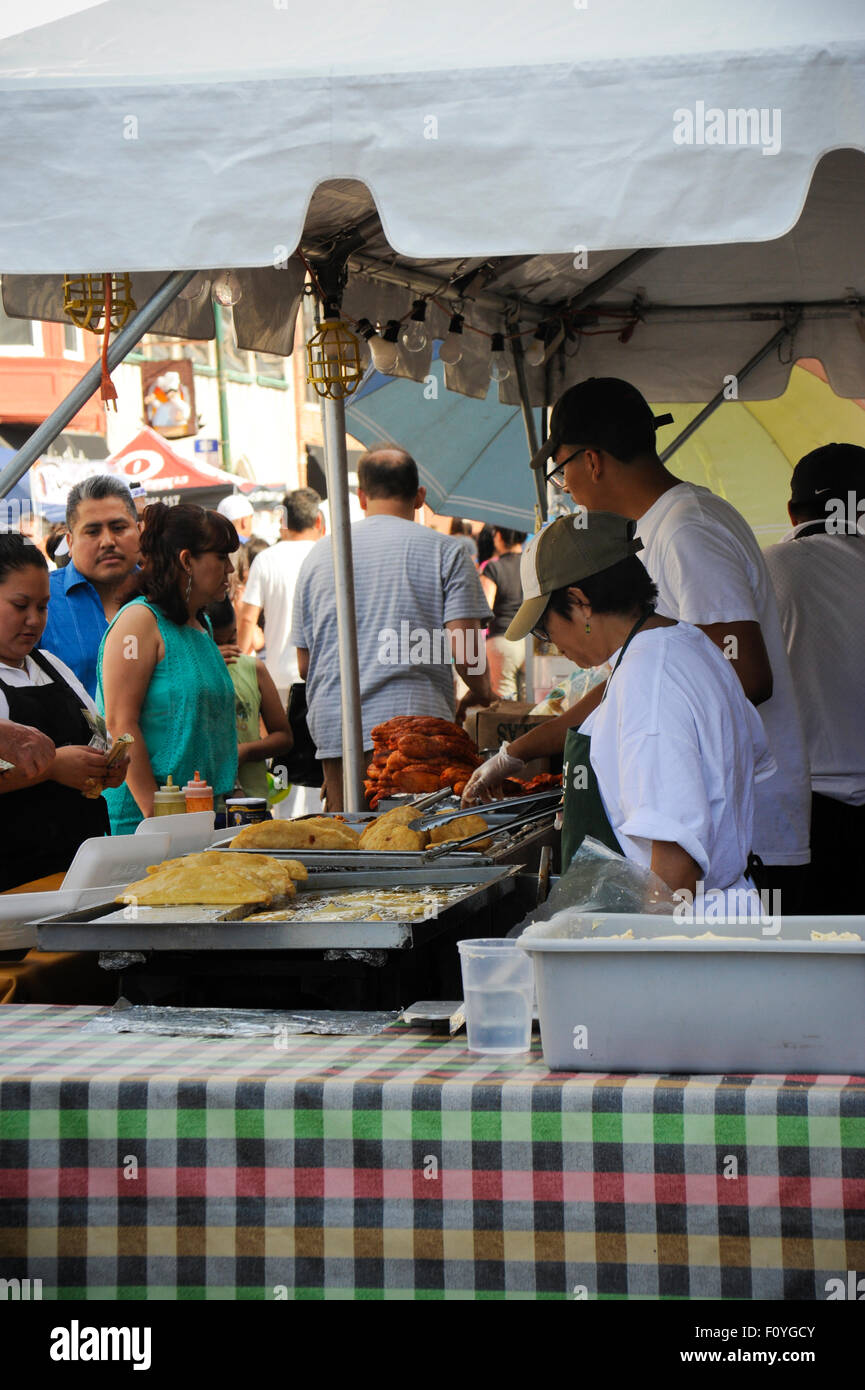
xmin=0 ymin=0 xmax=865 ymax=805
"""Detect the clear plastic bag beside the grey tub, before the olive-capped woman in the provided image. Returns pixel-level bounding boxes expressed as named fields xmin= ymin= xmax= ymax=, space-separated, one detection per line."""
xmin=509 ymin=835 xmax=679 ymax=937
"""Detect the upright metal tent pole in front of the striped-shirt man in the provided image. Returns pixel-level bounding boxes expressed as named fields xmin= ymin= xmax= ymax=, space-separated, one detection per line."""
xmin=321 ymin=396 xmax=366 ymax=810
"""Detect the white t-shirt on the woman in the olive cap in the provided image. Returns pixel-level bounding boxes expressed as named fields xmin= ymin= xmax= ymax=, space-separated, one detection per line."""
xmin=581 ymin=623 xmax=776 ymax=892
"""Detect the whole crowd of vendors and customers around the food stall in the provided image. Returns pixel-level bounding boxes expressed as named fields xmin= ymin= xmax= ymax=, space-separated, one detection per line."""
xmin=0 ymin=378 xmax=865 ymax=913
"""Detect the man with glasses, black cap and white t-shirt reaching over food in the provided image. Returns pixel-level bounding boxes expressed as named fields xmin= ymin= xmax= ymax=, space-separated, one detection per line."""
xmin=466 ymin=377 xmax=811 ymax=912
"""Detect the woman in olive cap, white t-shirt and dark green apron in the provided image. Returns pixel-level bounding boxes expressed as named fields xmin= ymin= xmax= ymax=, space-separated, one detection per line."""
xmin=463 ymin=512 xmax=775 ymax=904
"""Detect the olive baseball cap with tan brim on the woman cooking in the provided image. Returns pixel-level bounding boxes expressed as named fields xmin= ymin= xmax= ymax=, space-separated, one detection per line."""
xmin=505 ymin=512 xmax=642 ymax=642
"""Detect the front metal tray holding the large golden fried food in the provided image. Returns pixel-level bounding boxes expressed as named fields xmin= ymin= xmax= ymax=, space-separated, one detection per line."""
xmin=36 ymin=865 xmax=520 ymax=951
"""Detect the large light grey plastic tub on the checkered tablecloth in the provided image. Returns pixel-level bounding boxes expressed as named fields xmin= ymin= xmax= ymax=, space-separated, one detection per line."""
xmin=520 ymin=913 xmax=865 ymax=1076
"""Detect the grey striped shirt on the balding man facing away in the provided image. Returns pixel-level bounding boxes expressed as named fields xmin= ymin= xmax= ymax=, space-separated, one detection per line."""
xmin=292 ymin=514 xmax=491 ymax=758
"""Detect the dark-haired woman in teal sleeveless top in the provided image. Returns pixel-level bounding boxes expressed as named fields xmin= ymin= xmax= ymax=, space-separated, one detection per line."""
xmin=96 ymin=502 xmax=239 ymax=835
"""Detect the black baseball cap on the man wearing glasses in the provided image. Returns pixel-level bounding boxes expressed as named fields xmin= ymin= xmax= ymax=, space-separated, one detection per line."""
xmin=531 ymin=377 xmax=673 ymax=468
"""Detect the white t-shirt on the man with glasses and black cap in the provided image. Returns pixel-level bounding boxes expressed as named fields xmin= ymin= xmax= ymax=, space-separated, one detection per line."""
xmin=637 ymin=482 xmax=811 ymax=865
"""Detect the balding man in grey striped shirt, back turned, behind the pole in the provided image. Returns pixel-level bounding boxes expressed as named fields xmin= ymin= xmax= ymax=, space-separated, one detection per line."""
xmin=292 ymin=448 xmax=492 ymax=810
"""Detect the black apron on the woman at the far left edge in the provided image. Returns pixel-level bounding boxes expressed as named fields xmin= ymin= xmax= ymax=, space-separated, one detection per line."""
xmin=0 ymin=651 xmax=110 ymax=890
